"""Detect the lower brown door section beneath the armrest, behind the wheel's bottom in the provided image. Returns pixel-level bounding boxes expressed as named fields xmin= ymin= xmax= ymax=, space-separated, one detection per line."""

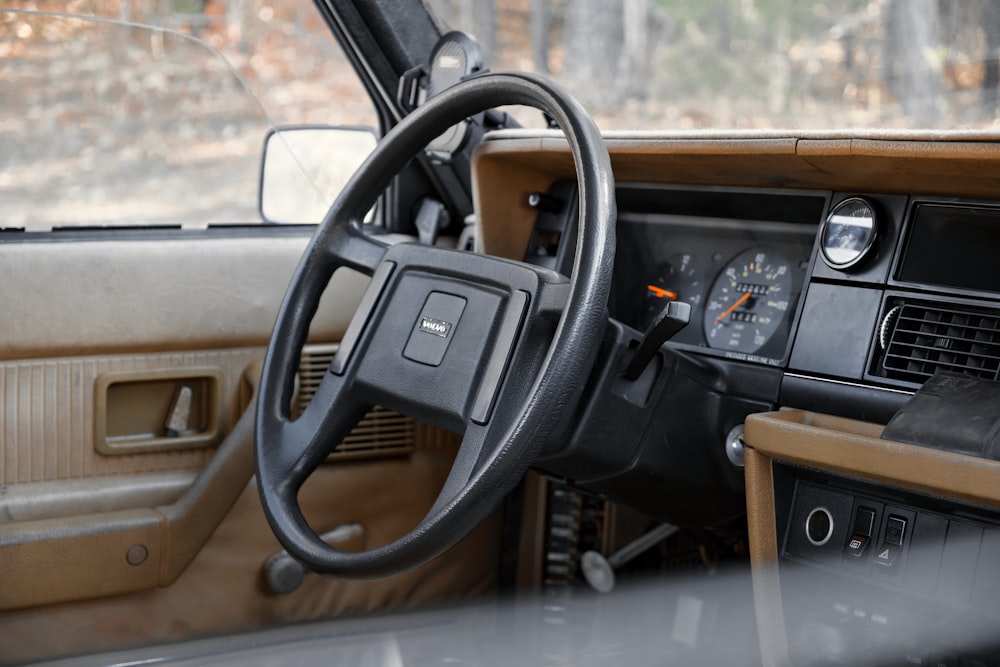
xmin=0 ymin=446 xmax=499 ymax=662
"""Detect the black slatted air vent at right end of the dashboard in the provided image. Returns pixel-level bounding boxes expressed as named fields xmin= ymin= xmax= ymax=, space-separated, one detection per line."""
xmin=882 ymin=303 xmax=1000 ymax=383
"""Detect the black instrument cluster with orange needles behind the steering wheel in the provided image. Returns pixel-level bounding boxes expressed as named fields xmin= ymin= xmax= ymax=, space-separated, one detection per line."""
xmin=612 ymin=200 xmax=818 ymax=365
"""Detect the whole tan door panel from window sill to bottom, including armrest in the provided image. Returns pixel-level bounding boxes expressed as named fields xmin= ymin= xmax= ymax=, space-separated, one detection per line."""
xmin=0 ymin=233 xmax=499 ymax=663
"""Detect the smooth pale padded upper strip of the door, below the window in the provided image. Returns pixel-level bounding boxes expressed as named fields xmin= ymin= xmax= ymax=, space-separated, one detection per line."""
xmin=0 ymin=232 xmax=367 ymax=360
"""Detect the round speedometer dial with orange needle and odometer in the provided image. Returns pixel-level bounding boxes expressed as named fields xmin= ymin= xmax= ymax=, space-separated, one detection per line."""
xmin=704 ymin=247 xmax=792 ymax=354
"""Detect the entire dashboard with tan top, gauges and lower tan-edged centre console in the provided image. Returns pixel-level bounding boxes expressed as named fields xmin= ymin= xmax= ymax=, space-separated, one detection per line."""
xmin=476 ymin=134 xmax=1000 ymax=664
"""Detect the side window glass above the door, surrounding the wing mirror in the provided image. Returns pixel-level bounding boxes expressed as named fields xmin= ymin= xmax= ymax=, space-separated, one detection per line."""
xmin=0 ymin=0 xmax=376 ymax=231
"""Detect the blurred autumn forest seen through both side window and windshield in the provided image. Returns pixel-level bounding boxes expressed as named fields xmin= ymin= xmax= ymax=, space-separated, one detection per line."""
xmin=0 ymin=0 xmax=1000 ymax=229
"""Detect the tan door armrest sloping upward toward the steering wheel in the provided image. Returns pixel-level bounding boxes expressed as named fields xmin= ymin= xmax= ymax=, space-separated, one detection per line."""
xmin=0 ymin=365 xmax=259 ymax=610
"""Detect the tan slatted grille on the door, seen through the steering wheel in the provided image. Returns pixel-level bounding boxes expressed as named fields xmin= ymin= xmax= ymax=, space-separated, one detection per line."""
xmin=292 ymin=345 xmax=416 ymax=459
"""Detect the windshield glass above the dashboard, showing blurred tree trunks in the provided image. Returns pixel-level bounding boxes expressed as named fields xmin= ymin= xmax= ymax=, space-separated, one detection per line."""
xmin=427 ymin=0 xmax=1000 ymax=130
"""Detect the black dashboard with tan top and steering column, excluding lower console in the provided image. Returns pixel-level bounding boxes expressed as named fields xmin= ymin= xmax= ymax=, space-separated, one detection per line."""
xmin=474 ymin=131 xmax=1000 ymax=525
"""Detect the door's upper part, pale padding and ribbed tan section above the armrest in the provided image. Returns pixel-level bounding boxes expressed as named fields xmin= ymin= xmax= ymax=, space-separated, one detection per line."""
xmin=0 ymin=234 xmax=426 ymax=486
